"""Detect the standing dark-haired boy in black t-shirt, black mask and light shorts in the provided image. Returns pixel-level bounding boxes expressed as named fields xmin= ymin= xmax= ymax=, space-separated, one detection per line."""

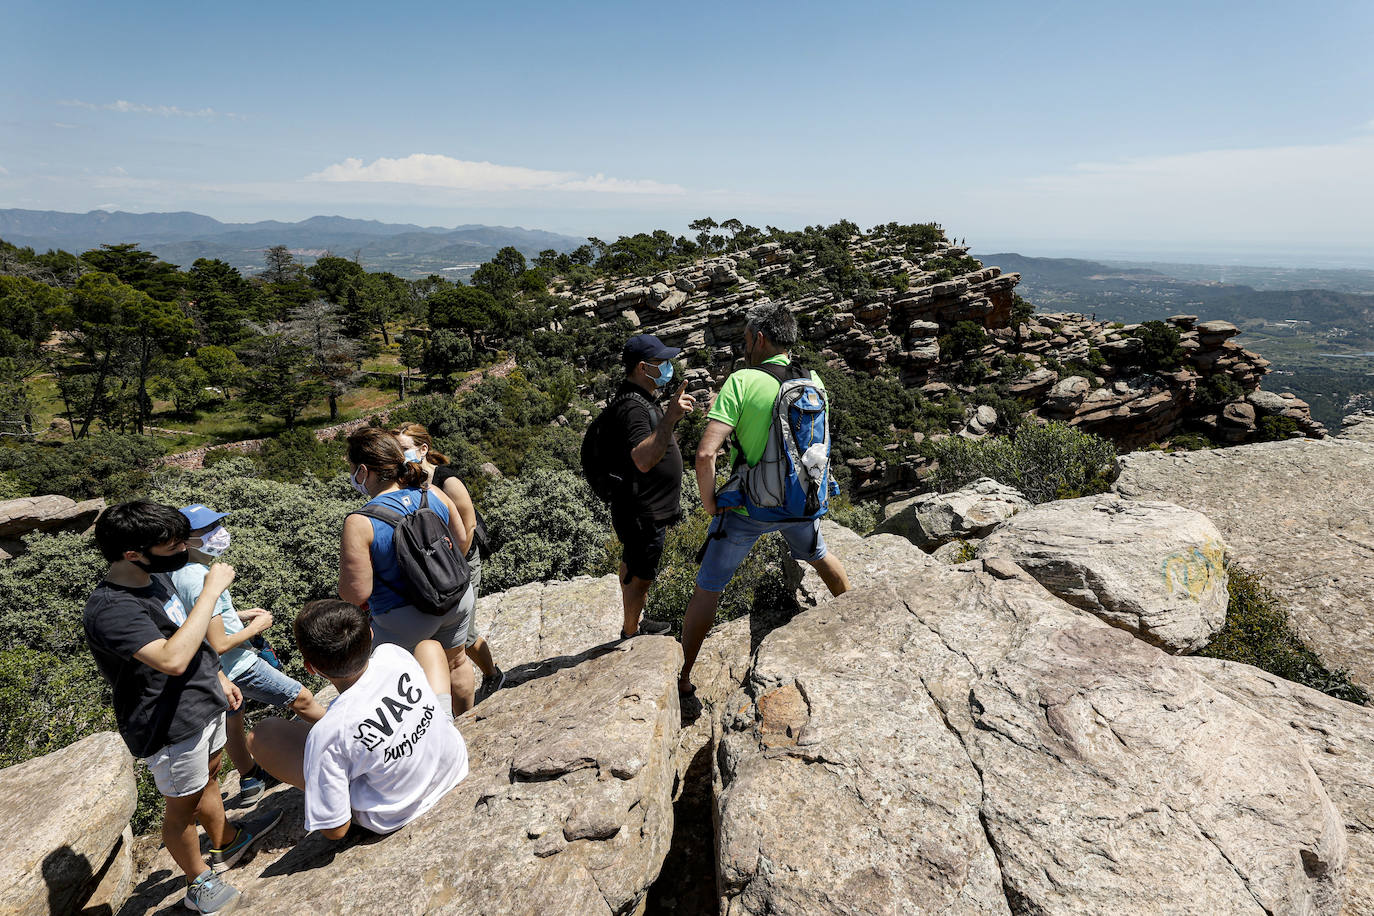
xmin=82 ymin=500 xmax=282 ymax=913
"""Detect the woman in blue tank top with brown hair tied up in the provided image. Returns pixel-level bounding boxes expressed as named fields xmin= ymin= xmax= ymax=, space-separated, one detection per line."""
xmin=339 ymin=428 xmax=477 ymax=715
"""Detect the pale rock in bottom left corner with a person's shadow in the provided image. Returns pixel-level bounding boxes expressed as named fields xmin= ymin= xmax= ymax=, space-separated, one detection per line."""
xmin=0 ymin=732 xmax=136 ymax=915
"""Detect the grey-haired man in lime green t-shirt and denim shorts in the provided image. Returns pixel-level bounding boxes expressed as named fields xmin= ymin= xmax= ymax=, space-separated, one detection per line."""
xmin=677 ymin=302 xmax=849 ymax=696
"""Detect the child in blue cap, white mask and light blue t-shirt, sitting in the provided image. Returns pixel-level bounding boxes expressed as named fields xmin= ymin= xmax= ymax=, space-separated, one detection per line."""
xmin=172 ymin=503 xmax=324 ymax=805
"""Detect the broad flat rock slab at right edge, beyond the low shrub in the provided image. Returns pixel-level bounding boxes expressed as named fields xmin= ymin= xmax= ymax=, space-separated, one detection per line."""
xmin=1116 ymin=436 xmax=1374 ymax=689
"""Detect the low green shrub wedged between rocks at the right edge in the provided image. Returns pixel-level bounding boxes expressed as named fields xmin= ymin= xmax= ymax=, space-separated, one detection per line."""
xmin=1198 ymin=563 xmax=1370 ymax=705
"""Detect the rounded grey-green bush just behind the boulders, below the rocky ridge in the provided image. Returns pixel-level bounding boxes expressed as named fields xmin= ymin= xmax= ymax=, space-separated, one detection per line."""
xmin=930 ymin=423 xmax=1116 ymax=503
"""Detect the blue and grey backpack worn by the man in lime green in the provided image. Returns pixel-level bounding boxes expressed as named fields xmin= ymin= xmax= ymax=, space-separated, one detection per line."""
xmin=716 ymin=363 xmax=840 ymax=522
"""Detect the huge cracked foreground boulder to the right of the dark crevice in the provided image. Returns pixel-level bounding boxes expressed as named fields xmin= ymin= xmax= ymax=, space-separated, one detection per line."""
xmin=714 ymin=526 xmax=1352 ymax=916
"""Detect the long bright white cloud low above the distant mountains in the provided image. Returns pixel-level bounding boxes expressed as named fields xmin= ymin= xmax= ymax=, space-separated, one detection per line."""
xmin=305 ymin=152 xmax=687 ymax=195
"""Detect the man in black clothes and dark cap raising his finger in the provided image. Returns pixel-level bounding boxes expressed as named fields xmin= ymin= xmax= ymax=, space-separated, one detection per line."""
xmin=606 ymin=334 xmax=697 ymax=639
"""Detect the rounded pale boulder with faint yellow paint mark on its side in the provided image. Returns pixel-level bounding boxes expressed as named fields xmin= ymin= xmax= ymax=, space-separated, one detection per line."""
xmin=978 ymin=496 xmax=1228 ymax=654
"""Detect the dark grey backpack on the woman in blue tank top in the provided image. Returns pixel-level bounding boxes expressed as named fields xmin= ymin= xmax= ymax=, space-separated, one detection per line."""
xmin=350 ymin=492 xmax=471 ymax=617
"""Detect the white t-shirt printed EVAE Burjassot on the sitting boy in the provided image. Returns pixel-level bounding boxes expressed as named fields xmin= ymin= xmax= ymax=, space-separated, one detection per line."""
xmin=305 ymin=644 xmax=467 ymax=834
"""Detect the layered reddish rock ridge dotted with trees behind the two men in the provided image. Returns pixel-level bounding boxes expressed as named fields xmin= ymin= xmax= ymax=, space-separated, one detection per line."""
xmin=563 ymin=228 xmax=1325 ymax=499
